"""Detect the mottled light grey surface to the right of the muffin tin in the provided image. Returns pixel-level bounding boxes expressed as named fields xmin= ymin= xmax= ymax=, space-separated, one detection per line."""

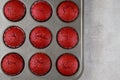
xmin=79 ymin=0 xmax=120 ymax=80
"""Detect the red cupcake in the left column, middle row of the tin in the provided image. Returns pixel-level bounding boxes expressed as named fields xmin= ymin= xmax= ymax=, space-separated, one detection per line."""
xmin=3 ymin=26 xmax=25 ymax=48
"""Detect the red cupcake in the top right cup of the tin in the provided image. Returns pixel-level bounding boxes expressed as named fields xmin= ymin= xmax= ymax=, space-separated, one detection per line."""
xmin=57 ymin=1 xmax=79 ymax=22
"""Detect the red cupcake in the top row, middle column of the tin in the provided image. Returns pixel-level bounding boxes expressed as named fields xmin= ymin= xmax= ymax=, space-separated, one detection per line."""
xmin=31 ymin=1 xmax=52 ymax=22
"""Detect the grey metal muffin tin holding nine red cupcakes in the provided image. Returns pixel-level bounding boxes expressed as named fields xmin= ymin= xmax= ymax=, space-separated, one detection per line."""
xmin=0 ymin=0 xmax=84 ymax=80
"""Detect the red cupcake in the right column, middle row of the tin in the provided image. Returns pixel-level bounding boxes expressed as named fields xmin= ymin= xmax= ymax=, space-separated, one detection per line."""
xmin=57 ymin=27 xmax=79 ymax=49
